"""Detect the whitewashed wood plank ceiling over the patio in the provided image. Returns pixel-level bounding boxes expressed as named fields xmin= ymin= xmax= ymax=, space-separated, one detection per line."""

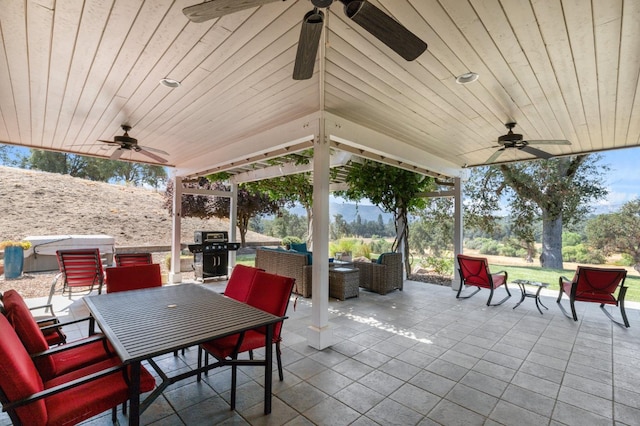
xmin=0 ymin=0 xmax=640 ymax=176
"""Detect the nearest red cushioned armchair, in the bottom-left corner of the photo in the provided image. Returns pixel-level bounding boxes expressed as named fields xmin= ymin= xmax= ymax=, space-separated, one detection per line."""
xmin=0 ymin=315 xmax=155 ymax=426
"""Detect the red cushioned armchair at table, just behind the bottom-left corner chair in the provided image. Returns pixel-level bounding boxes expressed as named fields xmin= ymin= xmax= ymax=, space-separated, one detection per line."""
xmin=3 ymin=290 xmax=116 ymax=380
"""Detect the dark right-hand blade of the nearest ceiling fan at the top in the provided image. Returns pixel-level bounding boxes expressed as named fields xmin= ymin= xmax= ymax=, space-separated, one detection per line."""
xmin=340 ymin=0 xmax=427 ymax=61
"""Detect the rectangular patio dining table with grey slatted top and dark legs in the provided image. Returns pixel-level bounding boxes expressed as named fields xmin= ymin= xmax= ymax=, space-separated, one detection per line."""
xmin=84 ymin=284 xmax=285 ymax=425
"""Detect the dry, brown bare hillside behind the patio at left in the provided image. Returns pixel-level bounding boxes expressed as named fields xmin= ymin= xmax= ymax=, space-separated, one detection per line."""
xmin=0 ymin=166 xmax=264 ymax=246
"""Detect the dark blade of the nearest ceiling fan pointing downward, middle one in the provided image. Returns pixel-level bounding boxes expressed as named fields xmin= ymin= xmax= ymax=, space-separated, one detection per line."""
xmin=293 ymin=8 xmax=324 ymax=80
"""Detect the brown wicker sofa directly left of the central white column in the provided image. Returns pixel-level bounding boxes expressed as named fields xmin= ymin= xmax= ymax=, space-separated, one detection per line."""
xmin=256 ymin=248 xmax=313 ymax=297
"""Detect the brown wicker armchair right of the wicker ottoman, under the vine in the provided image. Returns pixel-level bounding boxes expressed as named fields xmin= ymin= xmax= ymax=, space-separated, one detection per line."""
xmin=353 ymin=253 xmax=403 ymax=294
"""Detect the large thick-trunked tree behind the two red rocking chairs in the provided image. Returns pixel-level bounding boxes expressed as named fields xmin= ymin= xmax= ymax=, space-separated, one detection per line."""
xmin=466 ymin=155 xmax=609 ymax=269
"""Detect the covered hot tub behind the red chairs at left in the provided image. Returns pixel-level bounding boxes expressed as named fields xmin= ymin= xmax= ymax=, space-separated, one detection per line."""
xmin=24 ymin=235 xmax=115 ymax=272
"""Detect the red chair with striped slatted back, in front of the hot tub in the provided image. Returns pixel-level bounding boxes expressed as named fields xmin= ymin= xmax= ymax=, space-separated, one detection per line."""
xmin=47 ymin=249 xmax=104 ymax=303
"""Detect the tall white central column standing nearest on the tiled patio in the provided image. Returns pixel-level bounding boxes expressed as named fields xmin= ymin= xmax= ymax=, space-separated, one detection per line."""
xmin=307 ymin=118 xmax=333 ymax=349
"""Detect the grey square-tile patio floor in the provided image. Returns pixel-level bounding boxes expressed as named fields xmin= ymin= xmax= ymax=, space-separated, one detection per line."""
xmin=5 ymin=281 xmax=640 ymax=426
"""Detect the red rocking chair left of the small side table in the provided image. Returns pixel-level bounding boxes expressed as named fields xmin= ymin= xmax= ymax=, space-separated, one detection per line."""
xmin=456 ymin=254 xmax=511 ymax=306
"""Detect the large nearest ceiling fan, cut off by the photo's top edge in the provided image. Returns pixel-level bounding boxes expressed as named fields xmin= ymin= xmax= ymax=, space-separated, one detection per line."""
xmin=182 ymin=0 xmax=427 ymax=80
